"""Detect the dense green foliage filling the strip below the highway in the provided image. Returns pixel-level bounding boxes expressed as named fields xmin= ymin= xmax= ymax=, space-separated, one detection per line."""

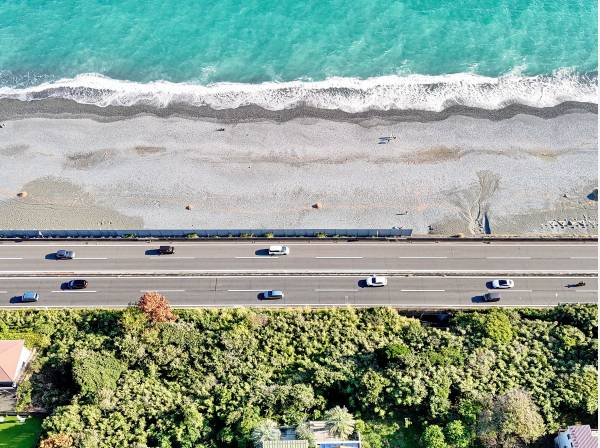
xmin=0 ymin=306 xmax=598 ymax=448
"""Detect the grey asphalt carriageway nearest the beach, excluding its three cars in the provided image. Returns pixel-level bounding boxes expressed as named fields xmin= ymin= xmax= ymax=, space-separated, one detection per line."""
xmin=0 ymin=241 xmax=598 ymax=275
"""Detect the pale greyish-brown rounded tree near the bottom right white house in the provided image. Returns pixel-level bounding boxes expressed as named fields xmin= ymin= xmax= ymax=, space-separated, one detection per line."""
xmin=477 ymin=389 xmax=544 ymax=448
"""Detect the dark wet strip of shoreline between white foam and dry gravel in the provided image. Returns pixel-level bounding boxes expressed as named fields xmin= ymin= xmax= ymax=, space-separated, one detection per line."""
xmin=0 ymin=98 xmax=598 ymax=124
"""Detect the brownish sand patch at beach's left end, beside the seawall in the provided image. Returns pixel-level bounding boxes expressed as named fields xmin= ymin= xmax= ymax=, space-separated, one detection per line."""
xmin=0 ymin=177 xmax=143 ymax=229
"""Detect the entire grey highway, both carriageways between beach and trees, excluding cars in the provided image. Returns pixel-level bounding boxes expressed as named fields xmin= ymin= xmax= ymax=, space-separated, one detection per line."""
xmin=0 ymin=241 xmax=598 ymax=309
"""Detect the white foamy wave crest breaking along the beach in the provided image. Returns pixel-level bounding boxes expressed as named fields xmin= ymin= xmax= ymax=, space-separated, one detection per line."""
xmin=0 ymin=69 xmax=598 ymax=113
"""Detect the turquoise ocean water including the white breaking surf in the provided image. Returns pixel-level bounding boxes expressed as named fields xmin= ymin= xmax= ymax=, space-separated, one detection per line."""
xmin=0 ymin=0 xmax=598 ymax=111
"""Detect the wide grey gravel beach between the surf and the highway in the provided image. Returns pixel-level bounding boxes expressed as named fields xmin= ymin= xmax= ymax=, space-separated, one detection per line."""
xmin=0 ymin=102 xmax=598 ymax=234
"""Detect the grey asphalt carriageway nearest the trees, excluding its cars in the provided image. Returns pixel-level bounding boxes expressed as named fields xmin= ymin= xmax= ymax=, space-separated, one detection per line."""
xmin=0 ymin=275 xmax=598 ymax=308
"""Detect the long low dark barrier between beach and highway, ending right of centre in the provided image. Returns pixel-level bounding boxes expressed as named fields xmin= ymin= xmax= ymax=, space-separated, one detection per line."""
xmin=0 ymin=229 xmax=412 ymax=239
